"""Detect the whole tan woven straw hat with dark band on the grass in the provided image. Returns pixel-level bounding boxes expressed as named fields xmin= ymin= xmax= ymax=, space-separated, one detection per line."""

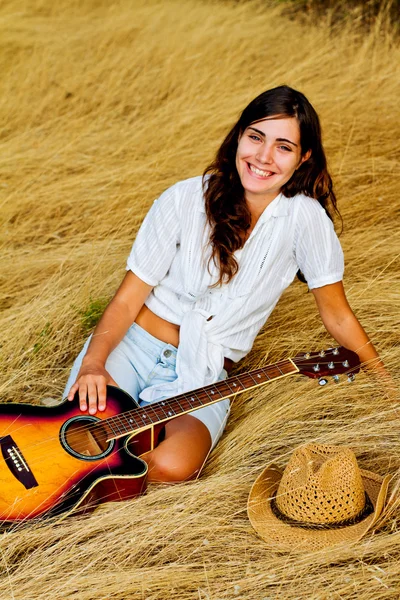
xmin=247 ymin=444 xmax=390 ymax=551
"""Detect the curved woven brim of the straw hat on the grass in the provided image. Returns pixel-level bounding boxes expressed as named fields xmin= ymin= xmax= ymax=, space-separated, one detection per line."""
xmin=247 ymin=466 xmax=390 ymax=552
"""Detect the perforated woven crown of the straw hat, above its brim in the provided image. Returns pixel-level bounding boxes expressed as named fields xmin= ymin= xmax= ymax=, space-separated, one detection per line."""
xmin=276 ymin=444 xmax=365 ymax=524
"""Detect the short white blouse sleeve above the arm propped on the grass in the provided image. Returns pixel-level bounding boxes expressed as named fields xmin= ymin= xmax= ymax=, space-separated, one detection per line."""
xmin=294 ymin=198 xmax=344 ymax=290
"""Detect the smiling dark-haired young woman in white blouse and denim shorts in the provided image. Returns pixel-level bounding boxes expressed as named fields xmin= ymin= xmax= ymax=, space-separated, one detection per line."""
xmin=66 ymin=86 xmax=379 ymax=481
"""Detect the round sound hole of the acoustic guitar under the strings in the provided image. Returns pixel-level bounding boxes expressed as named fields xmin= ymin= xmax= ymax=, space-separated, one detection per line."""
xmin=60 ymin=416 xmax=115 ymax=460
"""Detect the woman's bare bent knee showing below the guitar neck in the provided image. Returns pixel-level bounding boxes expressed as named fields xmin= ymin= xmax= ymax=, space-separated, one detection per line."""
xmin=141 ymin=415 xmax=211 ymax=483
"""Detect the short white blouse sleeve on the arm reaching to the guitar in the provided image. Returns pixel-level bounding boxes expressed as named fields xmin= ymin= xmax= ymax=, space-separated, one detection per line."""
xmin=126 ymin=186 xmax=180 ymax=287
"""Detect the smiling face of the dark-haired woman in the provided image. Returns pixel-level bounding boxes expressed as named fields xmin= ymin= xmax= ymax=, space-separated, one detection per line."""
xmin=236 ymin=117 xmax=310 ymax=206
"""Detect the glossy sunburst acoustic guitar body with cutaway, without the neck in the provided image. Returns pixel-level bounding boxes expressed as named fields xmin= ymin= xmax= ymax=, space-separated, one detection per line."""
xmin=0 ymin=386 xmax=163 ymax=526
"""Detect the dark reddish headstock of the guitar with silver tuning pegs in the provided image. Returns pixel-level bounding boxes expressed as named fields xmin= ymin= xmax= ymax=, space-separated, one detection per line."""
xmin=292 ymin=346 xmax=360 ymax=385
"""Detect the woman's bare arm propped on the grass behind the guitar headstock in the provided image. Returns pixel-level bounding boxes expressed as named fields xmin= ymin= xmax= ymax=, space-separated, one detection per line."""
xmin=311 ymin=281 xmax=388 ymax=376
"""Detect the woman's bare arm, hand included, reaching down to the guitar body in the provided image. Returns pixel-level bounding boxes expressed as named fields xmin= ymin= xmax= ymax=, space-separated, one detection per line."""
xmin=68 ymin=271 xmax=153 ymax=414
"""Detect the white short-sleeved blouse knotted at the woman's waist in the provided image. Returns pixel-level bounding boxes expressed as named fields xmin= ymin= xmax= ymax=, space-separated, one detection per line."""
xmin=127 ymin=177 xmax=344 ymax=402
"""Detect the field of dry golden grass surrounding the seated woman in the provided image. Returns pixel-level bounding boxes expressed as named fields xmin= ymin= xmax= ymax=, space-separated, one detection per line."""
xmin=0 ymin=0 xmax=400 ymax=600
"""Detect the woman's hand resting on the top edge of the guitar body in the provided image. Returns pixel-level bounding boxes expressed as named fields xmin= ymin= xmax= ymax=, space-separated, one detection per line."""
xmin=67 ymin=362 xmax=118 ymax=415
